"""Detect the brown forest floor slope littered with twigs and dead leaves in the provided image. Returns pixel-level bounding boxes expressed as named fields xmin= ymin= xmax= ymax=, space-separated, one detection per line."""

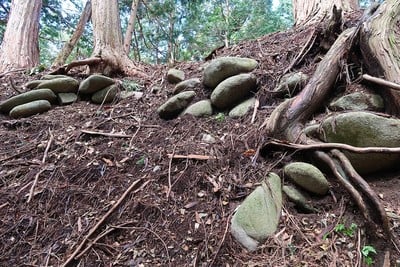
xmin=0 ymin=24 xmax=400 ymax=266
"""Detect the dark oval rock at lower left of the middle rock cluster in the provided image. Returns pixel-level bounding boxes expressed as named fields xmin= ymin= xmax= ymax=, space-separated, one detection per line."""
xmin=157 ymin=91 xmax=196 ymax=120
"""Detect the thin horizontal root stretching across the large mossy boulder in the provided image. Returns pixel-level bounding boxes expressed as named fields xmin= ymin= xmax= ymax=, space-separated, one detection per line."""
xmin=262 ymin=139 xmax=400 ymax=154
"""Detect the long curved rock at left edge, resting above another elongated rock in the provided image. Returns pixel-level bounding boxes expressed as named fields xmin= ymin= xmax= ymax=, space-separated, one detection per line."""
xmin=0 ymin=89 xmax=57 ymax=113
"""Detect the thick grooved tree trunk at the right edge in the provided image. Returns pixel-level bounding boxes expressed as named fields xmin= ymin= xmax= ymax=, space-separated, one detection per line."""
xmin=361 ymin=0 xmax=400 ymax=116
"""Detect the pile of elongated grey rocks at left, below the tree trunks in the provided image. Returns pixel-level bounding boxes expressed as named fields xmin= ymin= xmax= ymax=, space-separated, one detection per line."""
xmin=0 ymin=75 xmax=118 ymax=118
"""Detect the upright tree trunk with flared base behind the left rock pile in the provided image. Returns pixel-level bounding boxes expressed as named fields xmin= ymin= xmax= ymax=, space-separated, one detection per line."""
xmin=89 ymin=0 xmax=146 ymax=77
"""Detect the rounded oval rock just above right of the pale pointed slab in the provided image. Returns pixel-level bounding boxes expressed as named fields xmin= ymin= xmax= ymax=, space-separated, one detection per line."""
xmin=284 ymin=162 xmax=329 ymax=195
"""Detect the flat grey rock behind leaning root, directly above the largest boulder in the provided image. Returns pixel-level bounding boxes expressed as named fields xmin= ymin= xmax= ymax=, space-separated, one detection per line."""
xmin=329 ymin=92 xmax=385 ymax=111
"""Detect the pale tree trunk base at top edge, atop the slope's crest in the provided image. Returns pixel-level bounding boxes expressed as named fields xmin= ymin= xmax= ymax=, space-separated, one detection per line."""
xmin=293 ymin=0 xmax=358 ymax=26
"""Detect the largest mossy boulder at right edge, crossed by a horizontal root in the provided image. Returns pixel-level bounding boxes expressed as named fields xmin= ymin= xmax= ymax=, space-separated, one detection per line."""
xmin=318 ymin=111 xmax=400 ymax=174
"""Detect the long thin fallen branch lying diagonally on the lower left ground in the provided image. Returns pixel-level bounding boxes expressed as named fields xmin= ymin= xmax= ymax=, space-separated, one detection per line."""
xmin=62 ymin=179 xmax=150 ymax=267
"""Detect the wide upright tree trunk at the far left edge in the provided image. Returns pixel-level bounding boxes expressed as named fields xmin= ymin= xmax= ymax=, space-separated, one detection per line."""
xmin=0 ymin=0 xmax=42 ymax=72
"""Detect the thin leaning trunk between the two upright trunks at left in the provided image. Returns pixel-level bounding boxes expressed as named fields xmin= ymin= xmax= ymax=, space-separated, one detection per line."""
xmin=53 ymin=0 xmax=92 ymax=66
